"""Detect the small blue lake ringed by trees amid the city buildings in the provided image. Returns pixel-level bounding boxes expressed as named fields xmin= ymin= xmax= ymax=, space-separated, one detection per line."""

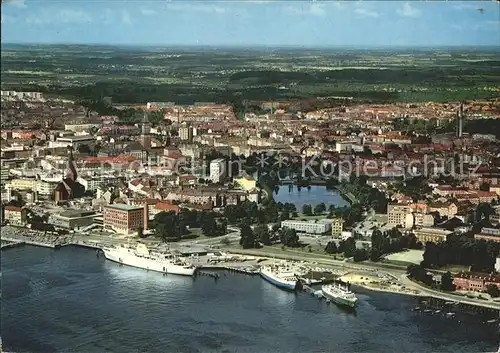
xmin=273 ymin=185 xmax=349 ymax=212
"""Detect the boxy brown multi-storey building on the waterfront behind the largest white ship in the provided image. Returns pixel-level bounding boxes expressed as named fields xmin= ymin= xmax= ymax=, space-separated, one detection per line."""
xmin=104 ymin=204 xmax=149 ymax=235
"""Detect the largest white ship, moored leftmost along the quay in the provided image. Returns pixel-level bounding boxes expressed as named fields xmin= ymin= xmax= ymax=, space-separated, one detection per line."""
xmin=102 ymin=243 xmax=196 ymax=276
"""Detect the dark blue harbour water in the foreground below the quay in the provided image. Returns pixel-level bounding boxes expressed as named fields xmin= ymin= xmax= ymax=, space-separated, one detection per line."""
xmin=1 ymin=246 xmax=497 ymax=353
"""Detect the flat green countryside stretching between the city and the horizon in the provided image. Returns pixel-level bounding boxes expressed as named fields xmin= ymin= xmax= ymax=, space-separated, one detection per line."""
xmin=1 ymin=45 xmax=500 ymax=105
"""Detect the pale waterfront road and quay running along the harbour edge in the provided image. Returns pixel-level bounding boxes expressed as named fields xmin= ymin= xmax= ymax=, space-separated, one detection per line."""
xmin=2 ymin=227 xmax=500 ymax=310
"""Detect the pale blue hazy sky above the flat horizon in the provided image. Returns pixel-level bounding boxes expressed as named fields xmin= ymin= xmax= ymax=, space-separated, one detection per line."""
xmin=1 ymin=0 xmax=500 ymax=47
